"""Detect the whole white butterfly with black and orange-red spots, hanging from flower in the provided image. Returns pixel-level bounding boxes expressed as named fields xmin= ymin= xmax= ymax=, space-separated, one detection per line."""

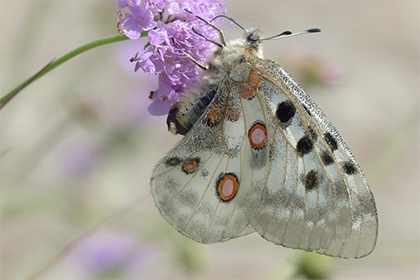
xmin=150 ymin=17 xmax=378 ymax=258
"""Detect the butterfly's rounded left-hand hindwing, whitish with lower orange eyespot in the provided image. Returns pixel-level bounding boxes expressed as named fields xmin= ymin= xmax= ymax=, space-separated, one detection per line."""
xmin=151 ymin=82 xmax=260 ymax=243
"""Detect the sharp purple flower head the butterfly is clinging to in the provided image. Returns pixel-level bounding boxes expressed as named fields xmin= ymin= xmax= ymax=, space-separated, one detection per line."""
xmin=118 ymin=0 xmax=226 ymax=115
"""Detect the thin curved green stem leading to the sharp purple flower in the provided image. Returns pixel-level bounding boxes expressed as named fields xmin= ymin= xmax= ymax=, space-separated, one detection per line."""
xmin=0 ymin=34 xmax=130 ymax=109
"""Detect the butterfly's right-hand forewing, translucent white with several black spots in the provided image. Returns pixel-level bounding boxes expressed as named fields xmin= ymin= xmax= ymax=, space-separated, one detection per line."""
xmin=248 ymin=59 xmax=377 ymax=258
